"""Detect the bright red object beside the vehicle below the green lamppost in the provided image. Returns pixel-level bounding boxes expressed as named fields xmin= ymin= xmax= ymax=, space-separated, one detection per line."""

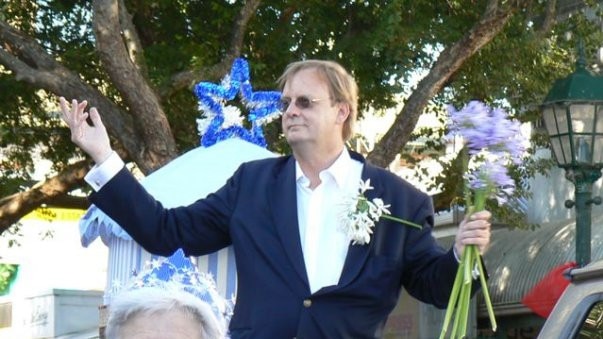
xmin=521 ymin=261 xmax=577 ymax=318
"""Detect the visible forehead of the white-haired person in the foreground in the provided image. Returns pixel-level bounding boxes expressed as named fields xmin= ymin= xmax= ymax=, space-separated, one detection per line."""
xmin=120 ymin=309 xmax=203 ymax=339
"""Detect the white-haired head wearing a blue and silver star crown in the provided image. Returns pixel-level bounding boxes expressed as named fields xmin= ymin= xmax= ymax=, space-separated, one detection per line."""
xmin=105 ymin=249 xmax=232 ymax=339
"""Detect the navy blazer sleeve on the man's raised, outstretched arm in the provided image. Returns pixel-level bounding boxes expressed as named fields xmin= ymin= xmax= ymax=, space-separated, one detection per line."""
xmin=89 ymin=167 xmax=241 ymax=256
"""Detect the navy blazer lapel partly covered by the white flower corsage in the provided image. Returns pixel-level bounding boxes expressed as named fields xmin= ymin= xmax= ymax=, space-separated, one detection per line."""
xmin=337 ymin=159 xmax=382 ymax=287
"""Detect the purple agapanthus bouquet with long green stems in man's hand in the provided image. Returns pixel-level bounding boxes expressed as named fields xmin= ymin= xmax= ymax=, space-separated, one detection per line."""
xmin=440 ymin=101 xmax=527 ymax=338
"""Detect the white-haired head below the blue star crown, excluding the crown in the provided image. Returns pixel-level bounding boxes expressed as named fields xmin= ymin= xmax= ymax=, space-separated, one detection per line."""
xmin=105 ymin=283 xmax=225 ymax=339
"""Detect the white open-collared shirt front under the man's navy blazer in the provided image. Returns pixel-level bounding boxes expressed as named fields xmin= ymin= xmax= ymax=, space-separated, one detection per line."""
xmin=295 ymin=149 xmax=362 ymax=293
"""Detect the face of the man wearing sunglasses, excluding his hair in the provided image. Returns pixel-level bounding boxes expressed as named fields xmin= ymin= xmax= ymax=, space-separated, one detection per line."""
xmin=282 ymin=68 xmax=347 ymax=148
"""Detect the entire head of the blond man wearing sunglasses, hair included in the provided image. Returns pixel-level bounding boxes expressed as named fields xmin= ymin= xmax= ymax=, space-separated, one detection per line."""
xmin=278 ymin=60 xmax=358 ymax=152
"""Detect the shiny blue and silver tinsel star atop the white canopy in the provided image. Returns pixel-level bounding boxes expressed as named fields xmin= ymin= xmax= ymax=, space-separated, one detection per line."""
xmin=194 ymin=58 xmax=281 ymax=147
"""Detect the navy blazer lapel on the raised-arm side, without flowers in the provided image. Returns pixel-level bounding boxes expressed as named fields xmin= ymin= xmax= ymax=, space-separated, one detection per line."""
xmin=270 ymin=156 xmax=310 ymax=289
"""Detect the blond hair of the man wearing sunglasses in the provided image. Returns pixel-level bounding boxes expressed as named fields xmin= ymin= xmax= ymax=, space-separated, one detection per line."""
xmin=277 ymin=59 xmax=358 ymax=141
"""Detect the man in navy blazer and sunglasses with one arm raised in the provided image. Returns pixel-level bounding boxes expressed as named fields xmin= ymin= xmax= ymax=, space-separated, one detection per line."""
xmin=61 ymin=60 xmax=490 ymax=339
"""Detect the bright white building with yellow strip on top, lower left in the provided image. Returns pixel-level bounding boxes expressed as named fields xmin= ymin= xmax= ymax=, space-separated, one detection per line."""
xmin=0 ymin=209 xmax=107 ymax=339
